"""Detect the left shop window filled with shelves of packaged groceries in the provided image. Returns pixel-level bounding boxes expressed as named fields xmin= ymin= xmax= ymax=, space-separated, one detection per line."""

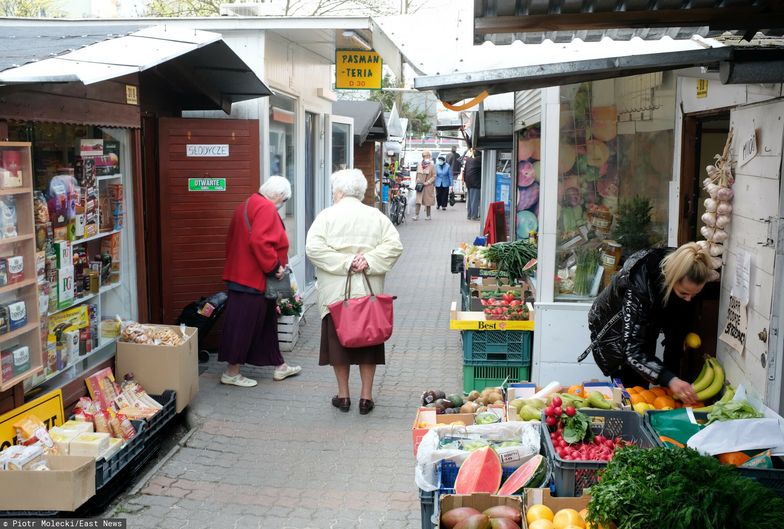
xmin=8 ymin=122 xmax=136 ymax=389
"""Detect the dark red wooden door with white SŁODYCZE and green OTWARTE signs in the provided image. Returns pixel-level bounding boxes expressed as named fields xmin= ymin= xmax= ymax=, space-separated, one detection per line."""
xmin=159 ymin=118 xmax=261 ymax=322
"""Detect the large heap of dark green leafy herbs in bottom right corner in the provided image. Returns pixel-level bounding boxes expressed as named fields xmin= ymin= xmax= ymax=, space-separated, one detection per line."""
xmin=588 ymin=447 xmax=784 ymax=529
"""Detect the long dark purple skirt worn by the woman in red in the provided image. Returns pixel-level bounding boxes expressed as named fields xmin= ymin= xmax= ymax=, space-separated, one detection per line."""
xmin=218 ymin=290 xmax=285 ymax=366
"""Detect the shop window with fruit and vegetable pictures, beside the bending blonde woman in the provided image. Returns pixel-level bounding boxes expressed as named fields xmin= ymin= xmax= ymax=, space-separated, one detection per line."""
xmin=556 ymin=77 xmax=675 ymax=302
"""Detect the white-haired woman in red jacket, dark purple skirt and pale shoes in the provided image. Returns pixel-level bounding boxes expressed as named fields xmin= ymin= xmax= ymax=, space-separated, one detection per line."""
xmin=218 ymin=176 xmax=302 ymax=388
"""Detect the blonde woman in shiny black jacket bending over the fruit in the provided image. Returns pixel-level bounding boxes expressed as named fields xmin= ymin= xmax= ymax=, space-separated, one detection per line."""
xmin=580 ymin=242 xmax=711 ymax=403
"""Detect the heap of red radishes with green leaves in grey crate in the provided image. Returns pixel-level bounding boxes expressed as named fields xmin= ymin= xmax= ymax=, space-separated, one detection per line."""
xmin=544 ymin=396 xmax=634 ymax=461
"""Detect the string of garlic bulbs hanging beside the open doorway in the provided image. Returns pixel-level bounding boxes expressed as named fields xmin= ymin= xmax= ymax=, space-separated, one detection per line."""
xmin=697 ymin=131 xmax=735 ymax=281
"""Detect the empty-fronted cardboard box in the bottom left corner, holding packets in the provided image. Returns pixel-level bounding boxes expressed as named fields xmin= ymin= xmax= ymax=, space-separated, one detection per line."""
xmin=0 ymin=456 xmax=95 ymax=512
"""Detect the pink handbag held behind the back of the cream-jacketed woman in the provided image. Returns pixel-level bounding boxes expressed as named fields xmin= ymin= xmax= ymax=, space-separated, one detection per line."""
xmin=327 ymin=271 xmax=395 ymax=348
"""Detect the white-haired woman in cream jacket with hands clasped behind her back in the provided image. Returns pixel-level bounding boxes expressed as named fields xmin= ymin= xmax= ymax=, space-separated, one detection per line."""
xmin=305 ymin=169 xmax=403 ymax=415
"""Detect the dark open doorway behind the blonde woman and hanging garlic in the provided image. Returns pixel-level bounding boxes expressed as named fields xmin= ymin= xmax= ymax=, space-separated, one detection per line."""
xmin=678 ymin=110 xmax=730 ymax=380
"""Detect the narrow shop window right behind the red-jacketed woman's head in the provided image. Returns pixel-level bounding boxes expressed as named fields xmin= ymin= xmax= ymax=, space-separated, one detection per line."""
xmin=269 ymin=95 xmax=300 ymax=253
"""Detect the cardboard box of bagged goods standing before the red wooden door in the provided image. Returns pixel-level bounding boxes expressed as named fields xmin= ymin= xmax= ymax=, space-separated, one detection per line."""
xmin=115 ymin=325 xmax=199 ymax=413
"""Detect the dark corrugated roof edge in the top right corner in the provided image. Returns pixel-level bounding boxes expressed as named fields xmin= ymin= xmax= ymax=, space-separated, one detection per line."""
xmin=473 ymin=0 xmax=784 ymax=44
